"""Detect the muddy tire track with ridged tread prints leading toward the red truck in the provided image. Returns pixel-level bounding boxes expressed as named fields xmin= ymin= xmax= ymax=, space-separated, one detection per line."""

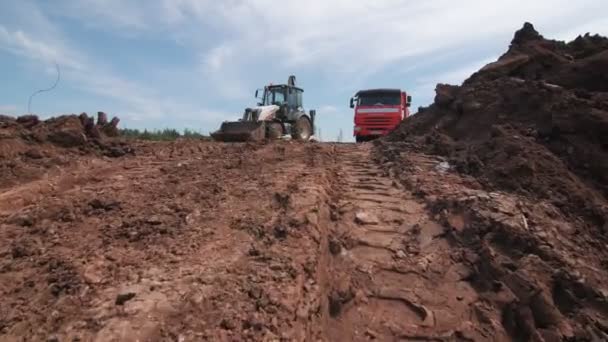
xmin=325 ymin=145 xmax=489 ymax=341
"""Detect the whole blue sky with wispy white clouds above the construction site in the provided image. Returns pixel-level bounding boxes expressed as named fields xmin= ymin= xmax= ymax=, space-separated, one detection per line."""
xmin=0 ymin=0 xmax=608 ymax=140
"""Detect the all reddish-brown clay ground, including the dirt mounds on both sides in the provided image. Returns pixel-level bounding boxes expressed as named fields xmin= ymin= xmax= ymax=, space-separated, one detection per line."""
xmin=0 ymin=22 xmax=608 ymax=341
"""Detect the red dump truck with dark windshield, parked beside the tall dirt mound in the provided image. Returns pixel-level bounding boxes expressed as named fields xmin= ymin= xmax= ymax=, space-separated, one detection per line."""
xmin=350 ymin=89 xmax=412 ymax=142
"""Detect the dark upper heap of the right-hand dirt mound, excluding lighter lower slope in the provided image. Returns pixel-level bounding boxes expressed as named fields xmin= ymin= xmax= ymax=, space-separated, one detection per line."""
xmin=388 ymin=23 xmax=608 ymax=226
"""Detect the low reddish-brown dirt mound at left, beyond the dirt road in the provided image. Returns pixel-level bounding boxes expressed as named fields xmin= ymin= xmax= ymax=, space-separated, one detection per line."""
xmin=0 ymin=112 xmax=133 ymax=188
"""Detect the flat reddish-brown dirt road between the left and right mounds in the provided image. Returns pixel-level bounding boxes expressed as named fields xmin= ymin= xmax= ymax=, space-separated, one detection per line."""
xmin=0 ymin=141 xmax=601 ymax=341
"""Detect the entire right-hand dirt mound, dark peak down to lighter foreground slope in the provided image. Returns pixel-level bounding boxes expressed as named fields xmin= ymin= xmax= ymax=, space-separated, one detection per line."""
xmin=377 ymin=23 xmax=608 ymax=341
